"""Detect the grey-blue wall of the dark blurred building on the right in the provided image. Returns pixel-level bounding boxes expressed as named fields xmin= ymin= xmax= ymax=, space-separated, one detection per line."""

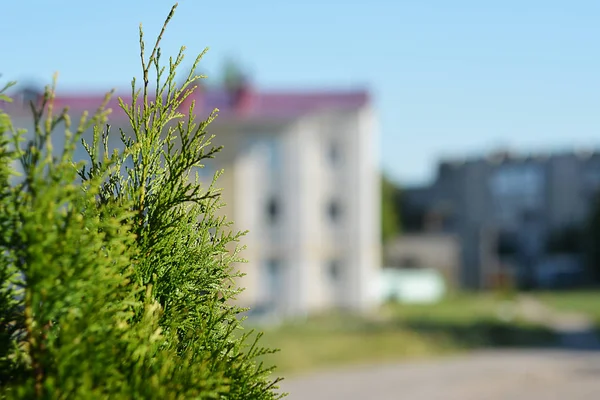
xmin=408 ymin=153 xmax=600 ymax=288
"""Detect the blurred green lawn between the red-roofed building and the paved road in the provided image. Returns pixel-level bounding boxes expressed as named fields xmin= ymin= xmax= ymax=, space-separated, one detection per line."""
xmin=253 ymin=295 xmax=554 ymax=376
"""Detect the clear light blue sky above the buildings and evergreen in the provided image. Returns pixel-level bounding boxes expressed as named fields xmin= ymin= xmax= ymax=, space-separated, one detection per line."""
xmin=0 ymin=0 xmax=600 ymax=184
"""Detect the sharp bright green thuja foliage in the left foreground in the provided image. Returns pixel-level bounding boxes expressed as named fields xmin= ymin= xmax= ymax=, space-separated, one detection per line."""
xmin=0 ymin=7 xmax=280 ymax=399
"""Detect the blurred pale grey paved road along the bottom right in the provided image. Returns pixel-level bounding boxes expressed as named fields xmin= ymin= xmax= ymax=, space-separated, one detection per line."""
xmin=281 ymin=350 xmax=600 ymax=400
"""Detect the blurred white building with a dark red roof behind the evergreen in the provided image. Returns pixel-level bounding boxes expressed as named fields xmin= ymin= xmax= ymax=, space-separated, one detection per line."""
xmin=3 ymin=83 xmax=380 ymax=316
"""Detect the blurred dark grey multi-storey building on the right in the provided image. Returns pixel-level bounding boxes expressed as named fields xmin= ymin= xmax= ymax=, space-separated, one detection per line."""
xmin=403 ymin=151 xmax=600 ymax=288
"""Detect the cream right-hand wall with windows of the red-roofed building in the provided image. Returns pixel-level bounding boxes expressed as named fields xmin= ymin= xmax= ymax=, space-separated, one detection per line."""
xmin=272 ymin=106 xmax=379 ymax=313
